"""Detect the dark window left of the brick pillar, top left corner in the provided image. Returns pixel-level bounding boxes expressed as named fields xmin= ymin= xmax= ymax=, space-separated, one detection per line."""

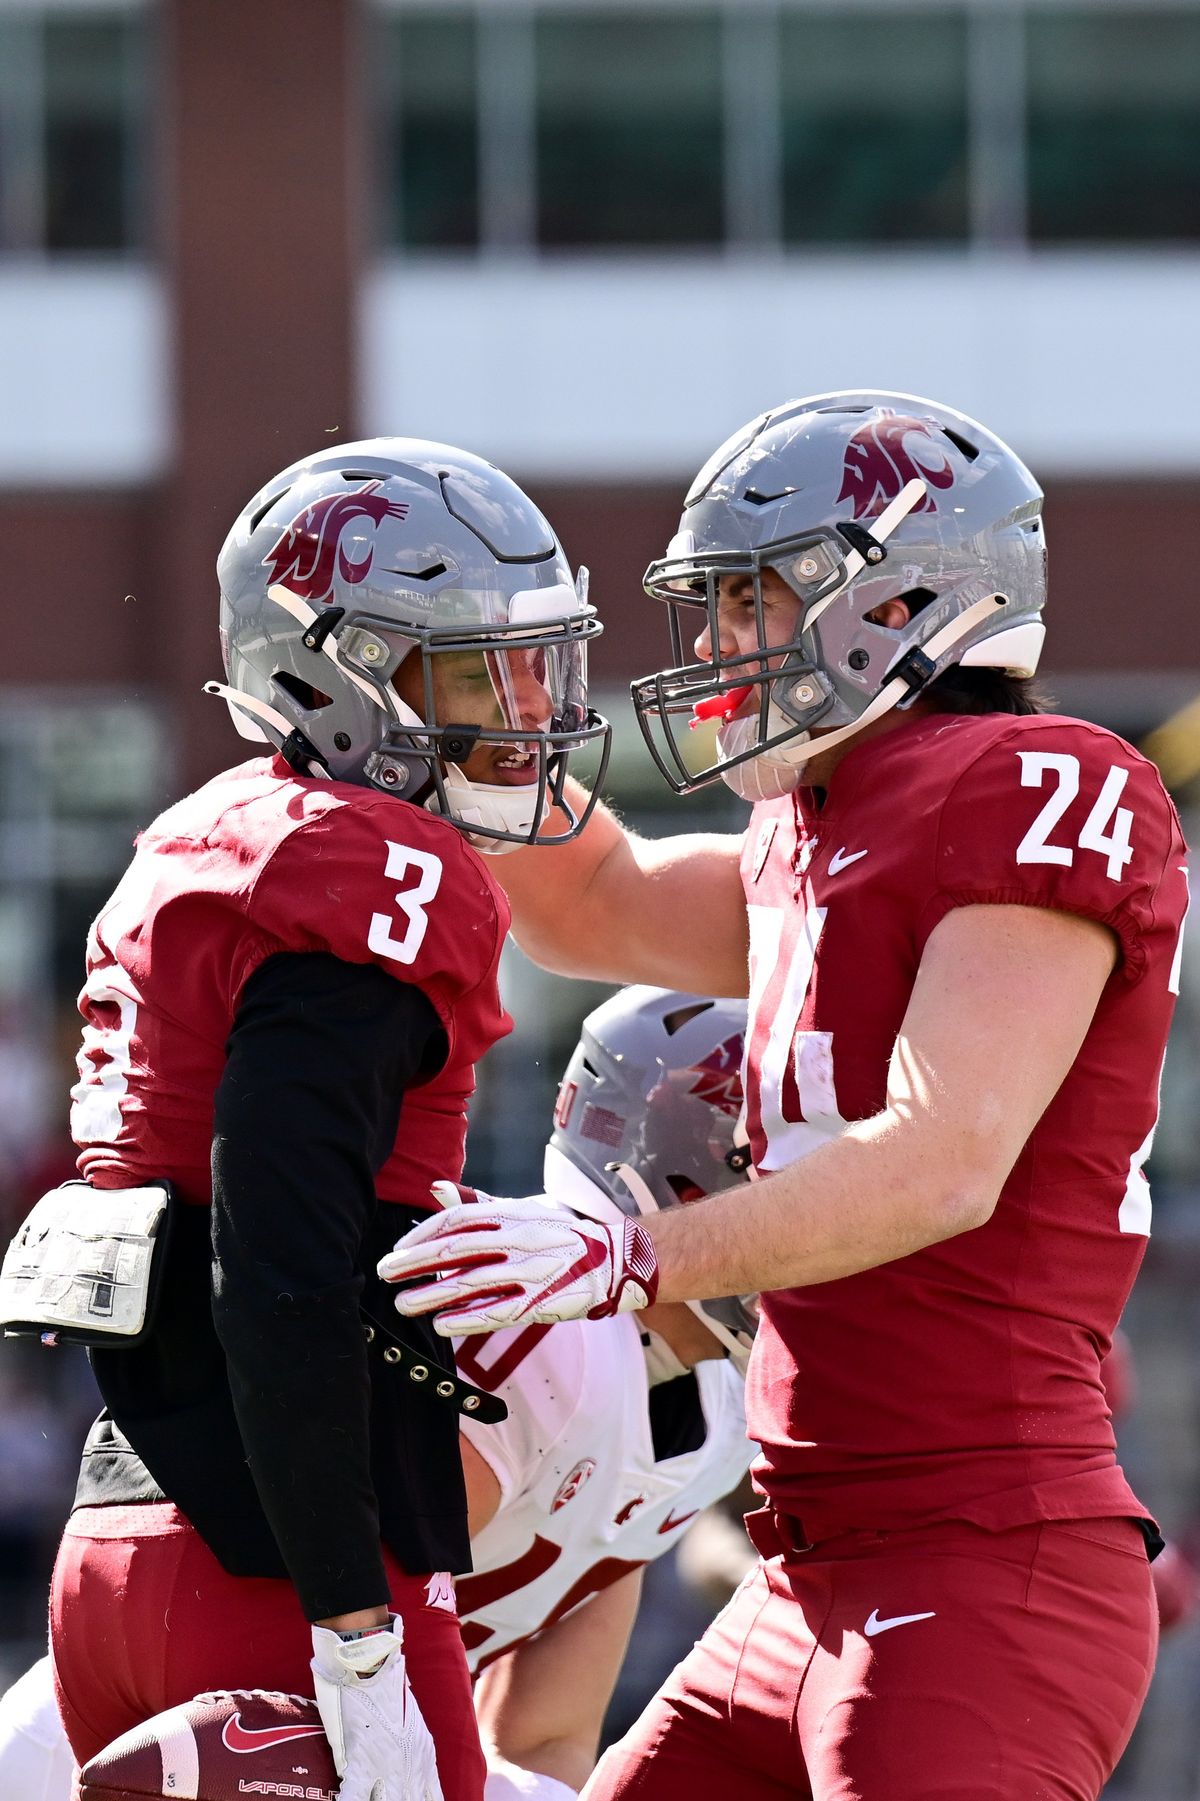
xmin=0 ymin=9 xmax=146 ymax=252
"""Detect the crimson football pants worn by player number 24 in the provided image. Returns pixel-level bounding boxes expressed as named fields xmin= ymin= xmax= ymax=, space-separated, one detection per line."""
xmin=584 ymin=1513 xmax=1159 ymax=1801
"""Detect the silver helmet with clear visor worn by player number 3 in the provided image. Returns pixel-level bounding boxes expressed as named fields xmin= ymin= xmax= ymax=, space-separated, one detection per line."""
xmin=209 ymin=438 xmax=609 ymax=850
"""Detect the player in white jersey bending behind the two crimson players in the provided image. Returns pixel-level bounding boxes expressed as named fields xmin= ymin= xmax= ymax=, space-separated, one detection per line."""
xmin=0 ymin=989 xmax=753 ymax=1801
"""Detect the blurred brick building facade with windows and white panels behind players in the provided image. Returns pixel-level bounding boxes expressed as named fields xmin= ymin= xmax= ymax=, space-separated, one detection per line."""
xmin=0 ymin=0 xmax=1200 ymax=1167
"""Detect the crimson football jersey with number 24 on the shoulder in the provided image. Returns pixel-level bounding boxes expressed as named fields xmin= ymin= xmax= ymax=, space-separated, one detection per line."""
xmin=742 ymin=713 xmax=1187 ymax=1538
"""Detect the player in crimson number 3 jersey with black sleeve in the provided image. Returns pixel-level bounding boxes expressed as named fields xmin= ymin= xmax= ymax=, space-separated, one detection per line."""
xmin=50 ymin=439 xmax=607 ymax=1801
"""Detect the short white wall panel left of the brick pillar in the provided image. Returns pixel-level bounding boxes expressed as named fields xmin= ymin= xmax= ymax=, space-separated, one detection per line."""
xmin=0 ymin=258 xmax=171 ymax=488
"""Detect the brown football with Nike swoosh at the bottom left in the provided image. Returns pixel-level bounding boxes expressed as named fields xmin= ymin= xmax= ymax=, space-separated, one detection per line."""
xmin=79 ymin=1689 xmax=337 ymax=1801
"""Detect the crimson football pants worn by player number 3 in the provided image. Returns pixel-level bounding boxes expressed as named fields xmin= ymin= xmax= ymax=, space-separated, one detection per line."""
xmin=50 ymin=1504 xmax=485 ymax=1801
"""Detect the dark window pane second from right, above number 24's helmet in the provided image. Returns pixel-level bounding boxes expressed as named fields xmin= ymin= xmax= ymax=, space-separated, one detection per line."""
xmin=780 ymin=7 xmax=968 ymax=243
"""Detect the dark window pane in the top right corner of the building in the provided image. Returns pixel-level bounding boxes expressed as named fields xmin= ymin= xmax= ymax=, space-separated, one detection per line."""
xmin=1025 ymin=7 xmax=1200 ymax=243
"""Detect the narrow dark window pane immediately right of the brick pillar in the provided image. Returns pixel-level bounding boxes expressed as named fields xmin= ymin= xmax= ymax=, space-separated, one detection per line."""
xmin=382 ymin=9 xmax=479 ymax=249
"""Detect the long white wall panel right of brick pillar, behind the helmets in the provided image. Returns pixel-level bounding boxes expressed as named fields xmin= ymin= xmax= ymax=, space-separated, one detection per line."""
xmin=362 ymin=252 xmax=1200 ymax=479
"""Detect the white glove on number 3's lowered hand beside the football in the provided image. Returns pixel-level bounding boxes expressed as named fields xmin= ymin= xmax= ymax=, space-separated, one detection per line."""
xmin=312 ymin=1614 xmax=443 ymax=1801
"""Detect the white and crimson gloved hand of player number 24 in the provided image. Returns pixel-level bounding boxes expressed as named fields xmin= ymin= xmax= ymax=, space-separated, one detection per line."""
xmin=378 ymin=1181 xmax=658 ymax=1338
